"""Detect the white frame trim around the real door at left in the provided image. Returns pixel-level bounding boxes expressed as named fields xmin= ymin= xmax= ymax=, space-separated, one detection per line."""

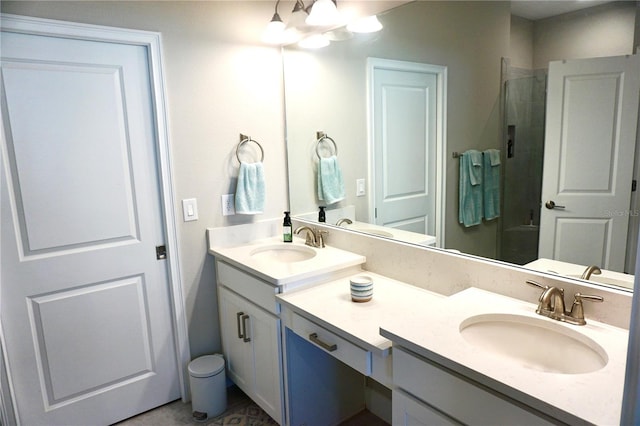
xmin=0 ymin=14 xmax=191 ymax=424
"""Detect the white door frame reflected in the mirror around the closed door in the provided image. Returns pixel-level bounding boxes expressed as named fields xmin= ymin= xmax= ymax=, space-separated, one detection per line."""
xmin=367 ymin=58 xmax=447 ymax=247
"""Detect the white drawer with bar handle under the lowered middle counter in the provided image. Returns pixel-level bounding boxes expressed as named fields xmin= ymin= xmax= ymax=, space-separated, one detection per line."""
xmin=289 ymin=312 xmax=371 ymax=376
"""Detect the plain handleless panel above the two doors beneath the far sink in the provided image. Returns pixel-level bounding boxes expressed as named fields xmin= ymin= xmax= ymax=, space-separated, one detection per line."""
xmin=216 ymin=261 xmax=280 ymax=315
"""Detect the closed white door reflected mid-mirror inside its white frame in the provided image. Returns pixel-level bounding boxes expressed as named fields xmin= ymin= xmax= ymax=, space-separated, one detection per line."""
xmin=370 ymin=60 xmax=442 ymax=235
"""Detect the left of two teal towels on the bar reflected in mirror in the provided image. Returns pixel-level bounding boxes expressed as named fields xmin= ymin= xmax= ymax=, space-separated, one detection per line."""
xmin=458 ymin=149 xmax=483 ymax=227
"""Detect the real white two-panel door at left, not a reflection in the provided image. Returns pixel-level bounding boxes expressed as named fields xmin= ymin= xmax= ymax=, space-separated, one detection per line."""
xmin=0 ymin=25 xmax=180 ymax=425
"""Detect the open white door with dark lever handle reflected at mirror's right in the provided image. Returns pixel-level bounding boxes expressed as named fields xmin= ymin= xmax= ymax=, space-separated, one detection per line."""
xmin=539 ymin=55 xmax=640 ymax=271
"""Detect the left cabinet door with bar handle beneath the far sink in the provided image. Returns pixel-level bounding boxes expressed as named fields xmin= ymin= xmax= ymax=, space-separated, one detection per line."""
xmin=218 ymin=287 xmax=253 ymax=393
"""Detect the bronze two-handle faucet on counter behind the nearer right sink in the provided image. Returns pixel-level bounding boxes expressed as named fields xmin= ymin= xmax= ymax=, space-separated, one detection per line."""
xmin=526 ymin=280 xmax=604 ymax=325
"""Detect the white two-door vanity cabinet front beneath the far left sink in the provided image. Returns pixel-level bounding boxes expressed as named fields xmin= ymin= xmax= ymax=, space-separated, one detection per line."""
xmin=216 ymin=261 xmax=283 ymax=424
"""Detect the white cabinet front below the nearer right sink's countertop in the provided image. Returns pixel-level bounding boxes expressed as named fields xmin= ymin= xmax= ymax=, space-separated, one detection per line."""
xmin=392 ymin=345 xmax=556 ymax=425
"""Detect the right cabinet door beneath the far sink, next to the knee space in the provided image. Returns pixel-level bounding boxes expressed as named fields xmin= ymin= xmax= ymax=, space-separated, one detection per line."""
xmin=247 ymin=305 xmax=283 ymax=423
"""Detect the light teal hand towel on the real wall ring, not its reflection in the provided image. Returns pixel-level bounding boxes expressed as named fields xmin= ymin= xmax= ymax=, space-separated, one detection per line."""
xmin=235 ymin=163 xmax=265 ymax=214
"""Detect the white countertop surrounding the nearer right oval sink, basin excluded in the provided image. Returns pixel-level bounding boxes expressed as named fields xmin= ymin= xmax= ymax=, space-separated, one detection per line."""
xmin=379 ymin=288 xmax=628 ymax=425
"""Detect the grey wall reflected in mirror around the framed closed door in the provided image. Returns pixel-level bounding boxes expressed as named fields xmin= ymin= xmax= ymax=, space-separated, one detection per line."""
xmin=285 ymin=1 xmax=510 ymax=257
